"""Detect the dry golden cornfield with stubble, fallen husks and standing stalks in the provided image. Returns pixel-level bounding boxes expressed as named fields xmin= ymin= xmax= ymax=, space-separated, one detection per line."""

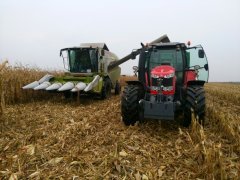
xmin=0 ymin=66 xmax=240 ymax=180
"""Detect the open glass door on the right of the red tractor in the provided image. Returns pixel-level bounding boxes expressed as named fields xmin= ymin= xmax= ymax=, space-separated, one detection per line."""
xmin=186 ymin=45 xmax=209 ymax=82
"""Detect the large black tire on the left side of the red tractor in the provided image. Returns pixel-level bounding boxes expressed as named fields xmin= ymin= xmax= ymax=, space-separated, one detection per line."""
xmin=121 ymin=85 xmax=142 ymax=126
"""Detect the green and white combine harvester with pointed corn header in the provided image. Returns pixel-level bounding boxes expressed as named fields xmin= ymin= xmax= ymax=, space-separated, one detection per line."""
xmin=23 ymin=43 xmax=121 ymax=99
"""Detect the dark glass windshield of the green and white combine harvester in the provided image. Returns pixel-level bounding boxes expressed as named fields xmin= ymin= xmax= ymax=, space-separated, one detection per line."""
xmin=68 ymin=49 xmax=98 ymax=73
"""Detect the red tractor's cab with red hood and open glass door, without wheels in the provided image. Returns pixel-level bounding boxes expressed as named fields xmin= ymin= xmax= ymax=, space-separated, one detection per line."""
xmin=138 ymin=43 xmax=208 ymax=96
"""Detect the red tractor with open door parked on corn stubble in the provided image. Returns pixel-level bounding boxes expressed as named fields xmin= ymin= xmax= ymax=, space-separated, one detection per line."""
xmin=121 ymin=36 xmax=209 ymax=126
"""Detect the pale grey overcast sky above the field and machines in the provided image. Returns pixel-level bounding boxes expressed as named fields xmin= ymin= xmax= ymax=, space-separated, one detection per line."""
xmin=0 ymin=0 xmax=240 ymax=81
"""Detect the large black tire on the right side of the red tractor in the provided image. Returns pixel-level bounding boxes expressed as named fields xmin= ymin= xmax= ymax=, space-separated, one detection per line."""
xmin=182 ymin=86 xmax=206 ymax=127
